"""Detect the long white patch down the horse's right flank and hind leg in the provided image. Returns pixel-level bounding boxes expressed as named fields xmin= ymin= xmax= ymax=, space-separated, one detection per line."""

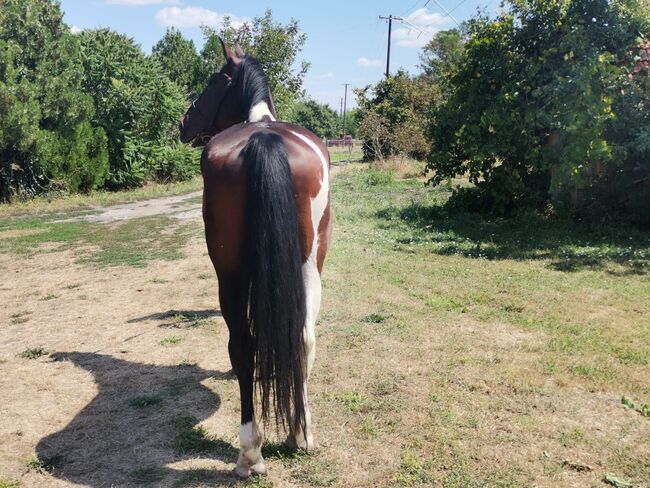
xmin=291 ymin=131 xmax=329 ymax=450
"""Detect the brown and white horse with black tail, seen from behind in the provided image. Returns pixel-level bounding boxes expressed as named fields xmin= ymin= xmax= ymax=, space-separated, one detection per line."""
xmin=179 ymin=40 xmax=332 ymax=478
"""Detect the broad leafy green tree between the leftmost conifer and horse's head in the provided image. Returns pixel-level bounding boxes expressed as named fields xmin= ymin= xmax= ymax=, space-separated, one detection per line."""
xmin=79 ymin=29 xmax=191 ymax=188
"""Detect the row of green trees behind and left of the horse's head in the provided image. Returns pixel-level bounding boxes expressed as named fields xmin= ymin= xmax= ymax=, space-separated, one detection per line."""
xmin=0 ymin=0 xmax=338 ymax=202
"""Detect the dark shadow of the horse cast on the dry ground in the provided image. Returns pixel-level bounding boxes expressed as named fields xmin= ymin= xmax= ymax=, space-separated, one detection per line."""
xmin=36 ymin=352 xmax=237 ymax=487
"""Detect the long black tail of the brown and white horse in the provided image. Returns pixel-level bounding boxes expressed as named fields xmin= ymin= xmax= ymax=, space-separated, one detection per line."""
xmin=241 ymin=132 xmax=306 ymax=438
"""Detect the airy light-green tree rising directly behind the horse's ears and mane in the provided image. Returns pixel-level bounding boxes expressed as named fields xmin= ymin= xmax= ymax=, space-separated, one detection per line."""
xmin=201 ymin=10 xmax=309 ymax=119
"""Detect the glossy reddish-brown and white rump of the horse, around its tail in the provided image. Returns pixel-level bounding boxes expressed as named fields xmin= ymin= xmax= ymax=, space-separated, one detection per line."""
xmin=201 ymin=122 xmax=329 ymax=272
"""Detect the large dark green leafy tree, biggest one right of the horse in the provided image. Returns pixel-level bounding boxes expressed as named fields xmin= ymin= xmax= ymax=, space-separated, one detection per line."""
xmin=428 ymin=0 xmax=647 ymax=217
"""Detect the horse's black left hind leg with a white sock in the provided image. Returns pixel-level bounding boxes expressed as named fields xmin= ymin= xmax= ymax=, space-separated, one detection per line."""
xmin=219 ymin=273 xmax=266 ymax=478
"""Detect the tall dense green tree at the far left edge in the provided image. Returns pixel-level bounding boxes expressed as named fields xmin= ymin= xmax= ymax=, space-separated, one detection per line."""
xmin=0 ymin=0 xmax=108 ymax=200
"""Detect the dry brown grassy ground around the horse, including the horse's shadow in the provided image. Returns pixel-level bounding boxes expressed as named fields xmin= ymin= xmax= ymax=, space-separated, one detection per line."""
xmin=0 ymin=168 xmax=650 ymax=487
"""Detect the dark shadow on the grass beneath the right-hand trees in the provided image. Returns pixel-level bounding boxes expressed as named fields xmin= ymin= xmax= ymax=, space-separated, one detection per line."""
xmin=376 ymin=202 xmax=650 ymax=274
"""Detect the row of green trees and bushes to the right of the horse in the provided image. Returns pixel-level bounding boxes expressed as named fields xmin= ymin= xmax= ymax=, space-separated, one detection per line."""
xmin=358 ymin=0 xmax=650 ymax=225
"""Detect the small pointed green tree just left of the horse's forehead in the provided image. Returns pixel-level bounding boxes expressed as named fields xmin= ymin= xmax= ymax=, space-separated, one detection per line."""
xmin=151 ymin=28 xmax=206 ymax=98
